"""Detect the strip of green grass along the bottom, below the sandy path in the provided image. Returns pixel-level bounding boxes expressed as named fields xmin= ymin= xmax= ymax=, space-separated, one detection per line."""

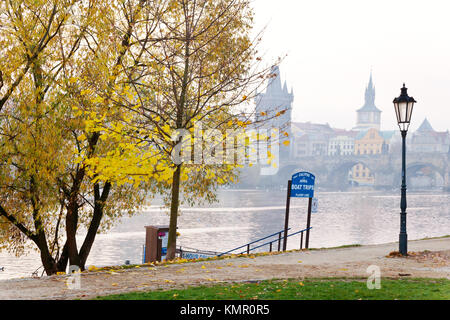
xmin=97 ymin=279 xmax=450 ymax=300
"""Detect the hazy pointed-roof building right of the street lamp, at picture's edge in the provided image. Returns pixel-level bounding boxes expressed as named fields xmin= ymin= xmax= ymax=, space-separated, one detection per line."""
xmin=410 ymin=118 xmax=450 ymax=153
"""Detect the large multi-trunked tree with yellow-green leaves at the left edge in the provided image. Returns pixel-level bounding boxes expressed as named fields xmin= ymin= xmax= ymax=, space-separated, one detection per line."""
xmin=0 ymin=0 xmax=165 ymax=274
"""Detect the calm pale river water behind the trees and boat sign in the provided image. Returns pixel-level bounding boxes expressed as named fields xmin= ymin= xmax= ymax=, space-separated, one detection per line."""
xmin=0 ymin=190 xmax=450 ymax=279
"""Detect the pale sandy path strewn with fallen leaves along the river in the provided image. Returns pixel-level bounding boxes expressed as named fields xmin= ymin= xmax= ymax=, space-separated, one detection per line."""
xmin=0 ymin=238 xmax=450 ymax=299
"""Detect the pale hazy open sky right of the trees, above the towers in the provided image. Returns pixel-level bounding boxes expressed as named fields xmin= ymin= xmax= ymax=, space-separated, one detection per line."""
xmin=253 ymin=0 xmax=450 ymax=131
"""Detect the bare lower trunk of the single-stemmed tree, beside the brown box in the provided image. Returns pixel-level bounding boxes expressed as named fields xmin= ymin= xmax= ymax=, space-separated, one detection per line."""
xmin=166 ymin=164 xmax=181 ymax=260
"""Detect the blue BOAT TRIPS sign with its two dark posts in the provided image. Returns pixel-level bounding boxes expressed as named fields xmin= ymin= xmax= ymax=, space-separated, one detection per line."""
xmin=283 ymin=172 xmax=316 ymax=251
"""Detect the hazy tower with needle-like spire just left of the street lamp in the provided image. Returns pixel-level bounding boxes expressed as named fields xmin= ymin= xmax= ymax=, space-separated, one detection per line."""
xmin=353 ymin=72 xmax=381 ymax=130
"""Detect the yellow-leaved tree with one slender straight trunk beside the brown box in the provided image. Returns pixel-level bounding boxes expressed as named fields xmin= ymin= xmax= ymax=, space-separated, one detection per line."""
xmin=81 ymin=0 xmax=278 ymax=259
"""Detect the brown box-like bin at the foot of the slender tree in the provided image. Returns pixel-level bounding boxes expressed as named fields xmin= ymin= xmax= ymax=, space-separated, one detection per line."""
xmin=144 ymin=226 xmax=169 ymax=263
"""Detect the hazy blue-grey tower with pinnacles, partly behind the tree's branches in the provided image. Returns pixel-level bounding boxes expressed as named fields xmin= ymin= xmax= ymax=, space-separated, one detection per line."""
xmin=255 ymin=66 xmax=294 ymax=160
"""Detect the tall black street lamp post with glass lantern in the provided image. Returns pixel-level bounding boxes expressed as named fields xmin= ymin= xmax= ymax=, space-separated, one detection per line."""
xmin=394 ymin=84 xmax=417 ymax=256
